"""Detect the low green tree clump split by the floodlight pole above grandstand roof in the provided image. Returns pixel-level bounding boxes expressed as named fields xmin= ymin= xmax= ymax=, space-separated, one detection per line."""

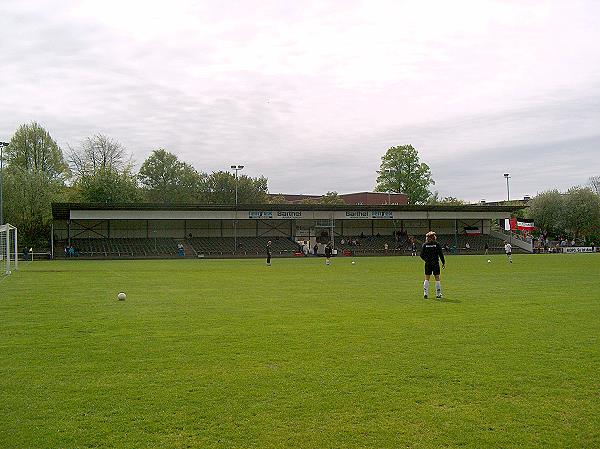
xmin=206 ymin=171 xmax=268 ymax=204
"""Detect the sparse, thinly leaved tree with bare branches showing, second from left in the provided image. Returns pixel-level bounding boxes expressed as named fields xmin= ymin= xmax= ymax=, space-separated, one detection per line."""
xmin=69 ymin=134 xmax=142 ymax=203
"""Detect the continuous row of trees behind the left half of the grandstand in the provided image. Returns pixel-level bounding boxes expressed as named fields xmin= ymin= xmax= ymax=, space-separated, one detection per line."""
xmin=2 ymin=122 xmax=278 ymax=243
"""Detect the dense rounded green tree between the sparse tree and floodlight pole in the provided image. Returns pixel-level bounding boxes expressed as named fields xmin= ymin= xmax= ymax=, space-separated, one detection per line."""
xmin=138 ymin=149 xmax=206 ymax=203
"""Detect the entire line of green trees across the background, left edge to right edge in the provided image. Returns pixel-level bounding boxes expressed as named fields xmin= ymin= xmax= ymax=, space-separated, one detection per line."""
xmin=3 ymin=122 xmax=600 ymax=243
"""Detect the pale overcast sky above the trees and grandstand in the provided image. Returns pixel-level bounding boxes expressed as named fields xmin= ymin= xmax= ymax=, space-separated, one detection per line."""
xmin=0 ymin=0 xmax=600 ymax=201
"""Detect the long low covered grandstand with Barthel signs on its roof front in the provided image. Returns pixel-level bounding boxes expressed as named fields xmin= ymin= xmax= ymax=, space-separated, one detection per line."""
xmin=52 ymin=203 xmax=514 ymax=257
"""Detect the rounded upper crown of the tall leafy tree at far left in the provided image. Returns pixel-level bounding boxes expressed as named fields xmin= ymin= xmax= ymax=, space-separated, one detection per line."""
xmin=5 ymin=122 xmax=69 ymax=179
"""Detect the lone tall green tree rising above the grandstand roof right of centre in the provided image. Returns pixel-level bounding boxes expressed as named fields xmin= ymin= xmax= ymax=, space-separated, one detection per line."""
xmin=375 ymin=145 xmax=435 ymax=204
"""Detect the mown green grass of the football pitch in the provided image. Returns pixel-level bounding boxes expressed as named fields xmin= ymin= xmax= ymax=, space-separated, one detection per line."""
xmin=0 ymin=255 xmax=600 ymax=448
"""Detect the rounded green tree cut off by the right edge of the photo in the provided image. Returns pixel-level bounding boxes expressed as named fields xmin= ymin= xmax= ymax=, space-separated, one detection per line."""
xmin=564 ymin=187 xmax=600 ymax=239
